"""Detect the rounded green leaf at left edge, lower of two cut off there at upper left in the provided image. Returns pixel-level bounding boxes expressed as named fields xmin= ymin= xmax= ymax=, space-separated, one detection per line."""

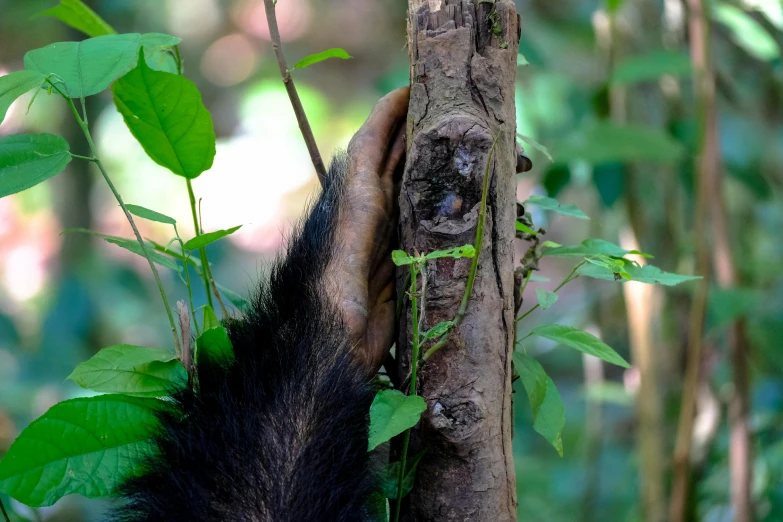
xmin=0 ymin=134 xmax=71 ymax=198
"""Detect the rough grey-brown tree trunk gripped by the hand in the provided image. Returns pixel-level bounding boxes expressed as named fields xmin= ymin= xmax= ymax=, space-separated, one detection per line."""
xmin=398 ymin=0 xmax=520 ymax=522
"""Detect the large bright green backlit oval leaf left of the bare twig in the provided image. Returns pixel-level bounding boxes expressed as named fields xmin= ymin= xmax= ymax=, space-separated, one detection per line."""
xmin=112 ymin=54 xmax=215 ymax=179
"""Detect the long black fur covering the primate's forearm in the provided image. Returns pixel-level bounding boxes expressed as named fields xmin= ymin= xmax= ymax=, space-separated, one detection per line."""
xmin=113 ymin=152 xmax=373 ymax=522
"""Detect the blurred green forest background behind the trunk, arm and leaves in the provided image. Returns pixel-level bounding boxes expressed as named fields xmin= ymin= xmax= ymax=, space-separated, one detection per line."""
xmin=0 ymin=0 xmax=783 ymax=522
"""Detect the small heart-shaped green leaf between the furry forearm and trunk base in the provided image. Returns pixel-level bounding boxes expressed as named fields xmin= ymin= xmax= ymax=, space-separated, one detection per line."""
xmin=368 ymin=390 xmax=427 ymax=451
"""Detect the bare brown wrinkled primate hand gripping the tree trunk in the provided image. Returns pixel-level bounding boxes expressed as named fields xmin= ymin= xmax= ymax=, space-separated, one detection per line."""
xmin=326 ymin=88 xmax=409 ymax=373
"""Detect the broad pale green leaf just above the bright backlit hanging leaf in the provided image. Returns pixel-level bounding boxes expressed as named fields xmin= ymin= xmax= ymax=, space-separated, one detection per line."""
xmin=24 ymin=33 xmax=141 ymax=98
